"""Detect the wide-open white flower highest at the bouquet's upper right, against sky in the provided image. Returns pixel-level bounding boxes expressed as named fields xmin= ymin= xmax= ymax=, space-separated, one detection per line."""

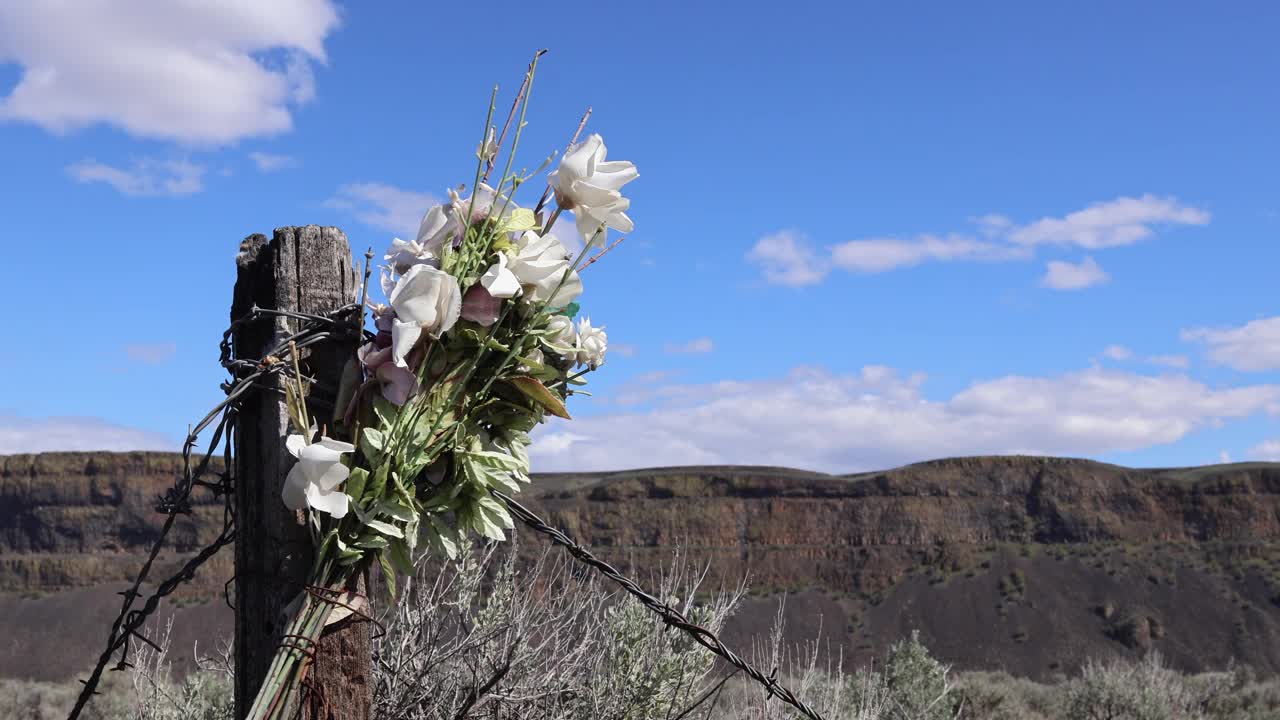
xmin=548 ymin=135 xmax=640 ymax=241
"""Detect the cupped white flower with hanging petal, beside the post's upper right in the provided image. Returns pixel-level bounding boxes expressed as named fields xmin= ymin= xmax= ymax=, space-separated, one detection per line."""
xmin=390 ymin=265 xmax=462 ymax=368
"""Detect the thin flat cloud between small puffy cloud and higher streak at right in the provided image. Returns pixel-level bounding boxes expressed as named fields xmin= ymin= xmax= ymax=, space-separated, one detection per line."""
xmin=831 ymin=234 xmax=1027 ymax=273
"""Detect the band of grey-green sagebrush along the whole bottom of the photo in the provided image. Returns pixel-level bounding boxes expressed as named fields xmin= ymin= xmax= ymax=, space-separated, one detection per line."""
xmin=45 ymin=546 xmax=1280 ymax=720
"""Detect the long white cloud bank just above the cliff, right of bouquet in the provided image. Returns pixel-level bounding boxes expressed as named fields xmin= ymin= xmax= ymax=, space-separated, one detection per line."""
xmin=532 ymin=366 xmax=1280 ymax=473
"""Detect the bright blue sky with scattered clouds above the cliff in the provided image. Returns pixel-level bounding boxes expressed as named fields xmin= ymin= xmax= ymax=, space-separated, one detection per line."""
xmin=0 ymin=0 xmax=1280 ymax=471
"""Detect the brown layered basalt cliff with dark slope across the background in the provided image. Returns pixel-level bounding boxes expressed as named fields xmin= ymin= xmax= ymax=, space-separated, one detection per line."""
xmin=0 ymin=452 xmax=1280 ymax=678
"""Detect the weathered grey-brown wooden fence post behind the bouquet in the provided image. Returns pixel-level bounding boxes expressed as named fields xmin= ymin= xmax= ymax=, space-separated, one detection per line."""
xmin=232 ymin=225 xmax=372 ymax=720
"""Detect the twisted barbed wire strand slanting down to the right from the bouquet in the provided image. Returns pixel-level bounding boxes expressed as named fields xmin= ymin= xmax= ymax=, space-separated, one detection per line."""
xmin=489 ymin=488 xmax=823 ymax=720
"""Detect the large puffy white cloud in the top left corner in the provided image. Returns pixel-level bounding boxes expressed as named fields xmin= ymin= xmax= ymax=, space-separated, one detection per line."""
xmin=0 ymin=0 xmax=338 ymax=145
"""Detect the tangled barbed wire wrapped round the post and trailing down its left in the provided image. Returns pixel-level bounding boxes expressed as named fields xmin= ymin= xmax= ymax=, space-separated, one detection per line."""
xmin=67 ymin=304 xmax=360 ymax=720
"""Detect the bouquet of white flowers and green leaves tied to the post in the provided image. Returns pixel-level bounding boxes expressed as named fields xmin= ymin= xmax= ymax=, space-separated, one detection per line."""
xmin=248 ymin=59 xmax=637 ymax=720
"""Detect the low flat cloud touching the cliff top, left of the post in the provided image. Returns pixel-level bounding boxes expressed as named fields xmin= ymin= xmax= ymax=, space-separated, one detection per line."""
xmin=0 ymin=415 xmax=172 ymax=455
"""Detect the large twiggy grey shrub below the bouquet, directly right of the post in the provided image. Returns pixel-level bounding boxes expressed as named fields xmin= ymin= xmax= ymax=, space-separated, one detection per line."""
xmin=374 ymin=546 xmax=741 ymax=720
